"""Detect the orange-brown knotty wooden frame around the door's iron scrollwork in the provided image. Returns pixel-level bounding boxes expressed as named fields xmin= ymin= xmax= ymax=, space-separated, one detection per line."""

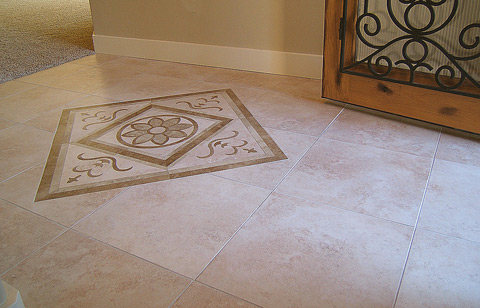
xmin=322 ymin=0 xmax=480 ymax=134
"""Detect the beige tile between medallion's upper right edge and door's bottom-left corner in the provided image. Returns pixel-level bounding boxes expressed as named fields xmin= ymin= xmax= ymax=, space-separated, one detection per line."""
xmin=245 ymin=92 xmax=344 ymax=136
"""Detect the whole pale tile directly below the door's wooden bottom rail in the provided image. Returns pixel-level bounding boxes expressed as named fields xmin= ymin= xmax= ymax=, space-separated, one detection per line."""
xmin=323 ymin=106 xmax=440 ymax=158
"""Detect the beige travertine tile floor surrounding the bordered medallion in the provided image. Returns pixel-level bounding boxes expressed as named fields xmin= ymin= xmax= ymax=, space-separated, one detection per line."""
xmin=0 ymin=54 xmax=480 ymax=308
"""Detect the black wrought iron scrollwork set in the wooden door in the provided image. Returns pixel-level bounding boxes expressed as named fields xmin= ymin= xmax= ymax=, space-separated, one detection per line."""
xmin=341 ymin=0 xmax=480 ymax=97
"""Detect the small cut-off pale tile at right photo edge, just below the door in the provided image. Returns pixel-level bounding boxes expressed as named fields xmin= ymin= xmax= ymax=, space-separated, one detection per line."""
xmin=437 ymin=129 xmax=480 ymax=167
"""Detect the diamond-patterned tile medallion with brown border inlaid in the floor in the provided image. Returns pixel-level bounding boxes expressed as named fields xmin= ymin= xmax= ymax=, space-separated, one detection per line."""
xmin=35 ymin=89 xmax=287 ymax=201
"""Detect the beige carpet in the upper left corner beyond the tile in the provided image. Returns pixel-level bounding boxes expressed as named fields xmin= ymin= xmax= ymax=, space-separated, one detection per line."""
xmin=0 ymin=0 xmax=94 ymax=83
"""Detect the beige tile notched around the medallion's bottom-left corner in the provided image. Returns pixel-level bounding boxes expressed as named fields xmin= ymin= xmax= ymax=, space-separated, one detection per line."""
xmin=0 ymin=164 xmax=122 ymax=226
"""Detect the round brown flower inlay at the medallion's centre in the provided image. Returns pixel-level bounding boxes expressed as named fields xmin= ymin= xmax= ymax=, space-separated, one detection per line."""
xmin=117 ymin=115 xmax=198 ymax=148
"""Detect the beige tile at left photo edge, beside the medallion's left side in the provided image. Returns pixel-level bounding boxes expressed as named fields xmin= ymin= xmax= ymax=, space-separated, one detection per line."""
xmin=0 ymin=124 xmax=53 ymax=181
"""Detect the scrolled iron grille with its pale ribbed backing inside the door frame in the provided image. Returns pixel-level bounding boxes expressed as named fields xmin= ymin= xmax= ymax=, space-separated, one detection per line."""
xmin=339 ymin=0 xmax=480 ymax=98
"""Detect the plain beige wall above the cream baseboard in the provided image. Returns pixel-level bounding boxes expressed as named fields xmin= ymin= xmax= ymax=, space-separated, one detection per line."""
xmin=90 ymin=0 xmax=324 ymax=55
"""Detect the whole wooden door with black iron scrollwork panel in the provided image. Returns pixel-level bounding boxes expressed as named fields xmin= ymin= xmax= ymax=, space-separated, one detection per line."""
xmin=322 ymin=0 xmax=480 ymax=133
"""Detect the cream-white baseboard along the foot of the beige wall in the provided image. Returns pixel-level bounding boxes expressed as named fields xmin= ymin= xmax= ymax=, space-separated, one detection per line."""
xmin=93 ymin=34 xmax=323 ymax=79
